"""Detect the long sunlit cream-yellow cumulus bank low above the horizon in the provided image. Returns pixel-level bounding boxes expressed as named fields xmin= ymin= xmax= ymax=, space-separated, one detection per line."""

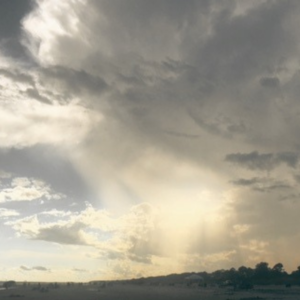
xmin=6 ymin=203 xmax=232 ymax=264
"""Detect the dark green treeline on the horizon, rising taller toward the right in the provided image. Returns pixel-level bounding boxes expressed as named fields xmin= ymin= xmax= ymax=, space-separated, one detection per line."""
xmin=126 ymin=262 xmax=300 ymax=288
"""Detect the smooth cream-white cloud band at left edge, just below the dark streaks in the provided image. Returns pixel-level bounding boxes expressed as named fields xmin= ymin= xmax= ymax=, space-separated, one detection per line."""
xmin=0 ymin=99 xmax=101 ymax=148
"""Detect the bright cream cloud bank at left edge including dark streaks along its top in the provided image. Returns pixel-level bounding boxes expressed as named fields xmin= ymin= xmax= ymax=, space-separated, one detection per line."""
xmin=0 ymin=66 xmax=105 ymax=148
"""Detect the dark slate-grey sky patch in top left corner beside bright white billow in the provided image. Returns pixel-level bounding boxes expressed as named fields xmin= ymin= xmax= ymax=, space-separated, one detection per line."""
xmin=0 ymin=0 xmax=33 ymax=59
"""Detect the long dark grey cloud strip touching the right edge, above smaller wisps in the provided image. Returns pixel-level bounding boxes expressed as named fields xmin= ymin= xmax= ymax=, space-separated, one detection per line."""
xmin=225 ymin=151 xmax=299 ymax=171
